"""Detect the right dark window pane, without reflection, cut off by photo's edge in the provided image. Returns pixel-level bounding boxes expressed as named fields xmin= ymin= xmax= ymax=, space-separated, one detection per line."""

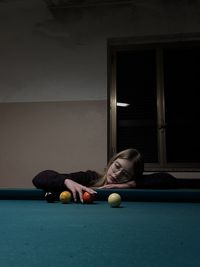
xmin=164 ymin=47 xmax=200 ymax=163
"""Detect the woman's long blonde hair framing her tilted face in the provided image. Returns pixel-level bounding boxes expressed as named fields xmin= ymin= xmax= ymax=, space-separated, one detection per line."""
xmin=93 ymin=148 xmax=144 ymax=187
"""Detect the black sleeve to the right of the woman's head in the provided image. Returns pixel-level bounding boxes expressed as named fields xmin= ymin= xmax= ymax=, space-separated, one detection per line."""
xmin=136 ymin=172 xmax=178 ymax=189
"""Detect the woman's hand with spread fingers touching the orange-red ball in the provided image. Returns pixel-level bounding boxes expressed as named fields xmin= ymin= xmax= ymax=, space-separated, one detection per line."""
xmin=64 ymin=179 xmax=97 ymax=202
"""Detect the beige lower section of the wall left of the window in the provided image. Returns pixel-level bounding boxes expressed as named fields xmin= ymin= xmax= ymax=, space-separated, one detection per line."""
xmin=0 ymin=101 xmax=107 ymax=188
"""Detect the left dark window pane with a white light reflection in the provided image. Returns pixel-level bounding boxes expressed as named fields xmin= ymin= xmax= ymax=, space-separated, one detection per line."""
xmin=117 ymin=50 xmax=158 ymax=162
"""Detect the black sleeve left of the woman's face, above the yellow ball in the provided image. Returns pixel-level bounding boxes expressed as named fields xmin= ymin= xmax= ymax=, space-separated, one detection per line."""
xmin=32 ymin=170 xmax=98 ymax=192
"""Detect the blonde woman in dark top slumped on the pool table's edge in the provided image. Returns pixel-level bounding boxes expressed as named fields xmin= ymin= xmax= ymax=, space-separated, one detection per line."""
xmin=32 ymin=148 xmax=177 ymax=202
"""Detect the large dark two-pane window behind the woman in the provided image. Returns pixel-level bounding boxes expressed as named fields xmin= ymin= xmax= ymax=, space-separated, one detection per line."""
xmin=108 ymin=35 xmax=200 ymax=170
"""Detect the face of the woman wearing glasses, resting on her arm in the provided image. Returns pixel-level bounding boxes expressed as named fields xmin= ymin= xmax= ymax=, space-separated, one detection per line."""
xmin=106 ymin=158 xmax=133 ymax=184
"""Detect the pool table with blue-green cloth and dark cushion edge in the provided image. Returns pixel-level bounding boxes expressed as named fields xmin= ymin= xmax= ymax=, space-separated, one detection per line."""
xmin=0 ymin=189 xmax=200 ymax=267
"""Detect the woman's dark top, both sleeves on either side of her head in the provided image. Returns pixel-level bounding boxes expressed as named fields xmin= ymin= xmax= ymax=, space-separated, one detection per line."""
xmin=33 ymin=170 xmax=178 ymax=192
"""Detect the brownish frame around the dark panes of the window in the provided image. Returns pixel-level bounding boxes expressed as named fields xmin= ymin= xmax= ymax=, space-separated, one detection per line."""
xmin=107 ymin=34 xmax=200 ymax=171
